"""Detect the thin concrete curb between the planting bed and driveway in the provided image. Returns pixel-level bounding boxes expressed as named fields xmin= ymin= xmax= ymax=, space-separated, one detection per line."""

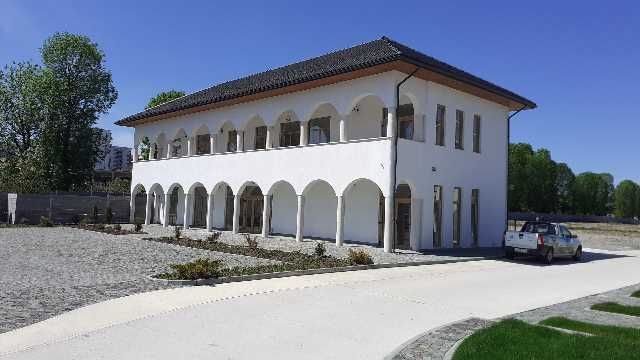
xmin=148 ymin=256 xmax=501 ymax=286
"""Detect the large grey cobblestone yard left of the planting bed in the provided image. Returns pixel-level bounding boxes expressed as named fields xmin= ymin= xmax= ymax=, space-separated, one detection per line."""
xmin=0 ymin=227 xmax=278 ymax=333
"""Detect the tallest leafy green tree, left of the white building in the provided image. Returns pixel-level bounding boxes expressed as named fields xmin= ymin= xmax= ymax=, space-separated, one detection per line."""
xmin=41 ymin=33 xmax=118 ymax=190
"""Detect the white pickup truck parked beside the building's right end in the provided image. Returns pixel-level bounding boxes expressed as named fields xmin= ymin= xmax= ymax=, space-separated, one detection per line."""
xmin=504 ymin=221 xmax=582 ymax=264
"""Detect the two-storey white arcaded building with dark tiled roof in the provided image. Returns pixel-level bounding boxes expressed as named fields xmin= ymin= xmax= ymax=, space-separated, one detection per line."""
xmin=117 ymin=37 xmax=536 ymax=251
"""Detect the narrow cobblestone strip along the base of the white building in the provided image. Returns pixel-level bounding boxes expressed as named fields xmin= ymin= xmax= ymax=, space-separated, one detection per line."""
xmin=145 ymin=225 xmax=504 ymax=264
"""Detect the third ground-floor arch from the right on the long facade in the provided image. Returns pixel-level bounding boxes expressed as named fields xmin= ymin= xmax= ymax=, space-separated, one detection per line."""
xmin=268 ymin=180 xmax=298 ymax=236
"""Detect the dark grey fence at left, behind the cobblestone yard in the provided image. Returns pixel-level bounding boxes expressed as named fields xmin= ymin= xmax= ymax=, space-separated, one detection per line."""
xmin=0 ymin=193 xmax=146 ymax=224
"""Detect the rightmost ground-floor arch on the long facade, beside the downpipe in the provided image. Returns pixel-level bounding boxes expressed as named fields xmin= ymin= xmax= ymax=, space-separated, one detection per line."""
xmin=342 ymin=178 xmax=384 ymax=245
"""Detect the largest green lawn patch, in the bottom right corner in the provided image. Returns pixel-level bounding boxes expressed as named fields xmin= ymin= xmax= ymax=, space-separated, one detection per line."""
xmin=453 ymin=318 xmax=640 ymax=360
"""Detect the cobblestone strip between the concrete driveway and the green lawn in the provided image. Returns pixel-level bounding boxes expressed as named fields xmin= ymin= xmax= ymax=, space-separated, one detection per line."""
xmin=391 ymin=318 xmax=493 ymax=360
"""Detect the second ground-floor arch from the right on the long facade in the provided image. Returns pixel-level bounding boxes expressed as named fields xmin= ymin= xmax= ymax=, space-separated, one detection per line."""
xmin=302 ymin=179 xmax=338 ymax=239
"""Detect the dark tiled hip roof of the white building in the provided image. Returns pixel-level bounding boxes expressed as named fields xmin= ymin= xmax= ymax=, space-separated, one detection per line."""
xmin=116 ymin=37 xmax=536 ymax=125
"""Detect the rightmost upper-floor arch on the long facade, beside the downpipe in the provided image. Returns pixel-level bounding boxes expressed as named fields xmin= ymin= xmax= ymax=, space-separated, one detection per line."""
xmin=345 ymin=94 xmax=387 ymax=140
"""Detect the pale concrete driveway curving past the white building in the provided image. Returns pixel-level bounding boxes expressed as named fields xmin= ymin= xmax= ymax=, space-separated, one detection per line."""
xmin=0 ymin=251 xmax=640 ymax=359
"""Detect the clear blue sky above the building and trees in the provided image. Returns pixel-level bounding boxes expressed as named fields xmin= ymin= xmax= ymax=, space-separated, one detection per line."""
xmin=0 ymin=0 xmax=640 ymax=182
